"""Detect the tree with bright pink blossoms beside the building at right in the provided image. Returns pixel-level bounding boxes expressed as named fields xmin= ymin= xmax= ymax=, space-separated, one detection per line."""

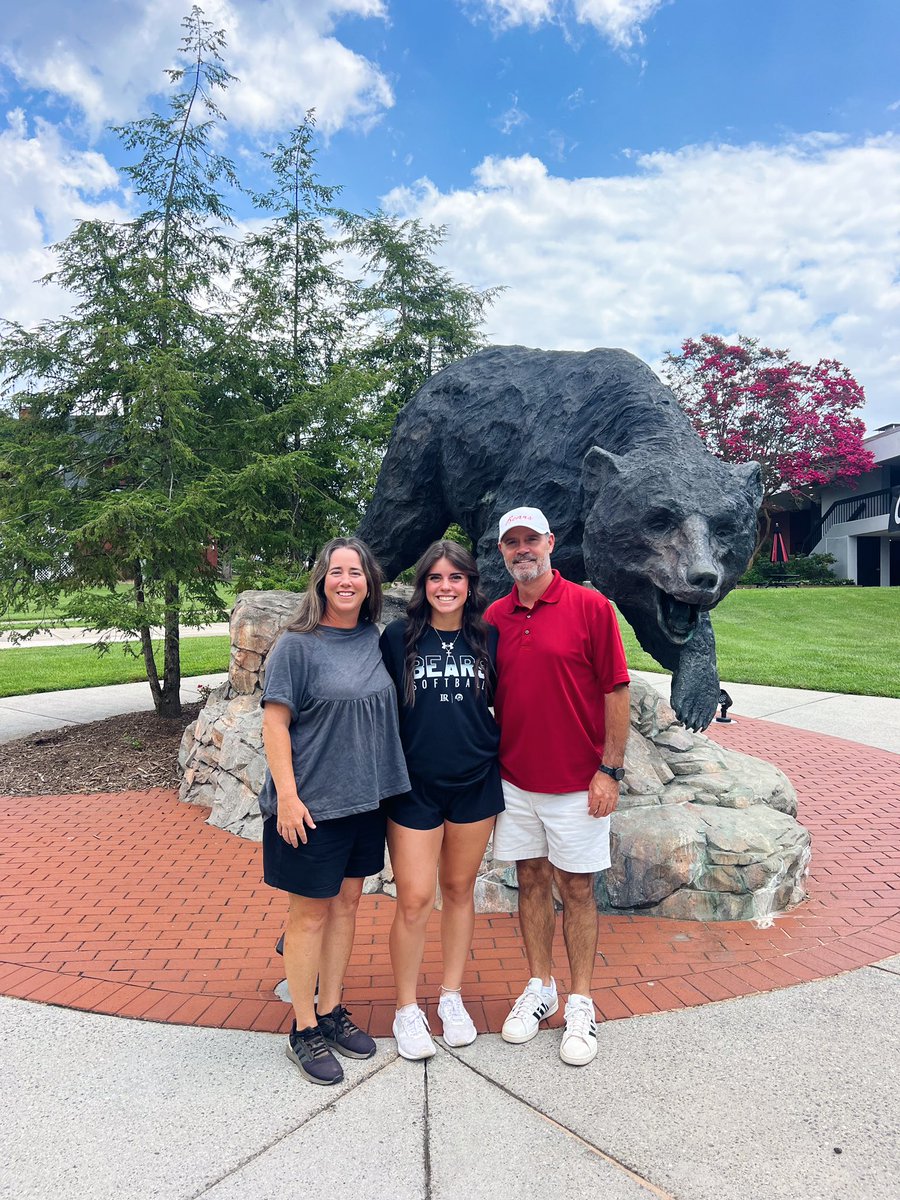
xmin=662 ymin=334 xmax=875 ymax=550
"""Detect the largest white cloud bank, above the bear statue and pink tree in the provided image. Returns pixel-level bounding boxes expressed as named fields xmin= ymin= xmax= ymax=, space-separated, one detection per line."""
xmin=385 ymin=136 xmax=900 ymax=427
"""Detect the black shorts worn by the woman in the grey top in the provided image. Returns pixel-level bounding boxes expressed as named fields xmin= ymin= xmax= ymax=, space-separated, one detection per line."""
xmin=263 ymin=805 xmax=385 ymax=900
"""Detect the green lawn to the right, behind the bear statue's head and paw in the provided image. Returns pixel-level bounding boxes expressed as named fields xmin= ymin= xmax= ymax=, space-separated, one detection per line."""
xmin=619 ymin=588 xmax=900 ymax=697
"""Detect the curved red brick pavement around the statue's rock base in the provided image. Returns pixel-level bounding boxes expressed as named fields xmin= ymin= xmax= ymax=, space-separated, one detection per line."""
xmin=0 ymin=719 xmax=900 ymax=1036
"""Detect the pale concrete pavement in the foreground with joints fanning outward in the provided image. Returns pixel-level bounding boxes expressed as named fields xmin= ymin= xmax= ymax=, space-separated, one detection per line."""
xmin=0 ymin=959 xmax=900 ymax=1200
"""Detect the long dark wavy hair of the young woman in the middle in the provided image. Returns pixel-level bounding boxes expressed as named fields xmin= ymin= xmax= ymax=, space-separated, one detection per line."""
xmin=403 ymin=540 xmax=494 ymax=707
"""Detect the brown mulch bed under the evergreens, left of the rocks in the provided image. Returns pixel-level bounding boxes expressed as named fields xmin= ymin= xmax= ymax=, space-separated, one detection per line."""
xmin=0 ymin=704 xmax=200 ymax=796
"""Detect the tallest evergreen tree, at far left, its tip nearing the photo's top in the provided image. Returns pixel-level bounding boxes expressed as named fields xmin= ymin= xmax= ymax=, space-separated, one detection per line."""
xmin=0 ymin=7 xmax=243 ymax=715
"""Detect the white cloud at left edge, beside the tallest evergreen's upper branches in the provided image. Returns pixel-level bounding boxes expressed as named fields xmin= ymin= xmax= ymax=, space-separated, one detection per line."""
xmin=0 ymin=109 xmax=127 ymax=325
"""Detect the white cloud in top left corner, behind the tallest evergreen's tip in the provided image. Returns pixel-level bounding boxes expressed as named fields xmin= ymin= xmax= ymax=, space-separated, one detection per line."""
xmin=0 ymin=0 xmax=394 ymax=133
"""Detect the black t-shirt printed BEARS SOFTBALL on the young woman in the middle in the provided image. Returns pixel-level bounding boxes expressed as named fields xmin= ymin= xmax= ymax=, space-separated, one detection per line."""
xmin=382 ymin=620 xmax=500 ymax=787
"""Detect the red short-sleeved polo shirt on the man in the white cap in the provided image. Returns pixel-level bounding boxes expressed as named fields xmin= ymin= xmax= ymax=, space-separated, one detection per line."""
xmin=485 ymin=571 xmax=630 ymax=792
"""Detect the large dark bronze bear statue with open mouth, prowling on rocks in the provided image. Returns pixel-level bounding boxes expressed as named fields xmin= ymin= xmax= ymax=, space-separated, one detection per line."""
xmin=359 ymin=346 xmax=762 ymax=730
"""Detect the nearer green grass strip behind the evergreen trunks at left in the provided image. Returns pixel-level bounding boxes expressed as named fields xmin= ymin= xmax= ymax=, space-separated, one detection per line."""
xmin=0 ymin=637 xmax=229 ymax=697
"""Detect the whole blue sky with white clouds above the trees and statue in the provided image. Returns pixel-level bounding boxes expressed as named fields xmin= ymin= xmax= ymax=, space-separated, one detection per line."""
xmin=0 ymin=0 xmax=900 ymax=428
